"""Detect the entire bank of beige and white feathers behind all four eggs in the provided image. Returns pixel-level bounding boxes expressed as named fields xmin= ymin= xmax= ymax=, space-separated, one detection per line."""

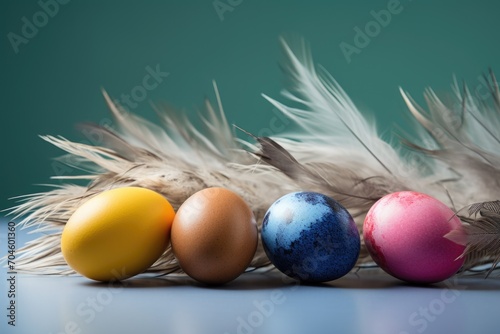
xmin=5 ymin=37 xmax=500 ymax=274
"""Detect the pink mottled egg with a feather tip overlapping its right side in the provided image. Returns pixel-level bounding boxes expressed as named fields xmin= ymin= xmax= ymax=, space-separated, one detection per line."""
xmin=363 ymin=191 xmax=465 ymax=283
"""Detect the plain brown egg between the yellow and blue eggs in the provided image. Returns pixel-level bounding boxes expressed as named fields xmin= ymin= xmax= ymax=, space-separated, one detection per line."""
xmin=171 ymin=188 xmax=258 ymax=284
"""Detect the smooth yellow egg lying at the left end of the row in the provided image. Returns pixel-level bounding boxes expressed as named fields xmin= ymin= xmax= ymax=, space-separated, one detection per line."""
xmin=61 ymin=187 xmax=175 ymax=281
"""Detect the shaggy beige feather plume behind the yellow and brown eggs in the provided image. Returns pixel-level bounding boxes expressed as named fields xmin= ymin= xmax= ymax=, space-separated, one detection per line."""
xmin=7 ymin=84 xmax=297 ymax=274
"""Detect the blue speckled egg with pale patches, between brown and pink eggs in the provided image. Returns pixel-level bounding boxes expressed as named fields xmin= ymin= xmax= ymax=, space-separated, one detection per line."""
xmin=261 ymin=192 xmax=360 ymax=282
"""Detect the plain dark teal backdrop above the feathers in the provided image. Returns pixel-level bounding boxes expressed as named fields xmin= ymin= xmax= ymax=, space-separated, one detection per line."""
xmin=0 ymin=0 xmax=500 ymax=208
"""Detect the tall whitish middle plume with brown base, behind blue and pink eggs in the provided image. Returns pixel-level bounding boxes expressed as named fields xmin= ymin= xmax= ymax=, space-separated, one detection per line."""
xmin=254 ymin=38 xmax=464 ymax=262
